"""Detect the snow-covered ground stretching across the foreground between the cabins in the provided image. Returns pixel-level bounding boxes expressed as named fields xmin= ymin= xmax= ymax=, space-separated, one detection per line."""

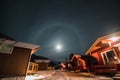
xmin=0 ymin=70 xmax=120 ymax=80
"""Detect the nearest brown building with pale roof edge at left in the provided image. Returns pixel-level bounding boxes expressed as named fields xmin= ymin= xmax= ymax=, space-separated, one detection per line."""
xmin=0 ymin=38 xmax=40 ymax=77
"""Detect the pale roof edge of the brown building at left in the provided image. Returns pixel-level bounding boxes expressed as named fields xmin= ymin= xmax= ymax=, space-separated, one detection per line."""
xmin=0 ymin=38 xmax=40 ymax=53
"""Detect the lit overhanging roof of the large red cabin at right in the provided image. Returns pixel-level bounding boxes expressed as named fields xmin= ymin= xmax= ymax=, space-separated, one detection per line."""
xmin=85 ymin=31 xmax=120 ymax=54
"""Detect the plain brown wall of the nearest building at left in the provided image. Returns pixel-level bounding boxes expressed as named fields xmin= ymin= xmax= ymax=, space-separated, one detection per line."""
xmin=0 ymin=47 xmax=31 ymax=76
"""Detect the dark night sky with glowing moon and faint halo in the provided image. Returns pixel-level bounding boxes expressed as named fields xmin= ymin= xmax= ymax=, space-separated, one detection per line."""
xmin=0 ymin=0 xmax=120 ymax=61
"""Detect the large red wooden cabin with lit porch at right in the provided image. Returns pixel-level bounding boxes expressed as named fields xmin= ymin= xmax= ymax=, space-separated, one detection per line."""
xmin=85 ymin=32 xmax=120 ymax=73
